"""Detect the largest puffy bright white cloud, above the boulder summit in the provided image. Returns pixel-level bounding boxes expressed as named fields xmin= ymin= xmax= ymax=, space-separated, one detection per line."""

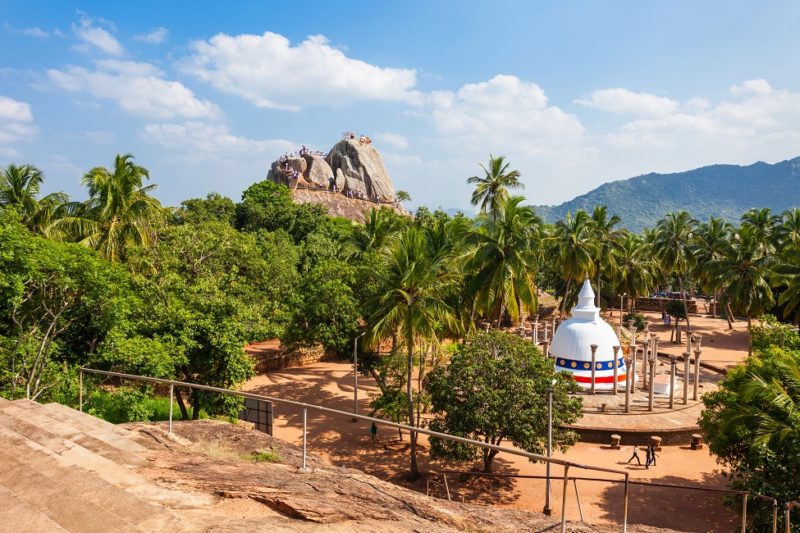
xmin=179 ymin=32 xmax=419 ymax=111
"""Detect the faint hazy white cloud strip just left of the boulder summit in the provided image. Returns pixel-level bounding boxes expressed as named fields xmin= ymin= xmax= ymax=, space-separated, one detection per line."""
xmin=140 ymin=121 xmax=296 ymax=154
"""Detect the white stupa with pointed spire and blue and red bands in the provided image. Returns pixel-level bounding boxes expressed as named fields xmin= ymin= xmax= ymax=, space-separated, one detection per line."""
xmin=550 ymin=279 xmax=627 ymax=390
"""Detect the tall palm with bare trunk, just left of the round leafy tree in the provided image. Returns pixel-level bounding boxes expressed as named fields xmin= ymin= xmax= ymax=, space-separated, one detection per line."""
xmin=369 ymin=227 xmax=456 ymax=477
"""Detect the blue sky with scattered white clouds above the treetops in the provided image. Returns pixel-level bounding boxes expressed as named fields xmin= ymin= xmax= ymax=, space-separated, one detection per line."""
xmin=0 ymin=0 xmax=800 ymax=208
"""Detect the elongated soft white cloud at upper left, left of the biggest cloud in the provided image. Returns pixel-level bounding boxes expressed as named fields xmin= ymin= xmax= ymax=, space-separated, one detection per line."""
xmin=47 ymin=59 xmax=220 ymax=119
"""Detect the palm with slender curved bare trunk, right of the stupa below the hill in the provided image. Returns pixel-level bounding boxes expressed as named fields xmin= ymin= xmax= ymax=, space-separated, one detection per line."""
xmin=653 ymin=211 xmax=697 ymax=330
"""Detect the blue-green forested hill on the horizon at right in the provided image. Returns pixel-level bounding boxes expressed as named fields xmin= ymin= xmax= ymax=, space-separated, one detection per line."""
xmin=536 ymin=157 xmax=800 ymax=231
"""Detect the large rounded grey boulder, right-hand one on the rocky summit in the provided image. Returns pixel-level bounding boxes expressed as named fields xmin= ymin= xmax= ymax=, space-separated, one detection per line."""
xmin=325 ymin=139 xmax=395 ymax=202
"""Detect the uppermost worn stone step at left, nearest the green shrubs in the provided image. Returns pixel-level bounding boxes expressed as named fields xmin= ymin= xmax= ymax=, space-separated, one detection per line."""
xmin=0 ymin=402 xmax=146 ymax=465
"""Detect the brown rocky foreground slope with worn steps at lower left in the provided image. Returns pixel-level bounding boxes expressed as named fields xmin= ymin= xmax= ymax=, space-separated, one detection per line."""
xmin=0 ymin=398 xmax=680 ymax=532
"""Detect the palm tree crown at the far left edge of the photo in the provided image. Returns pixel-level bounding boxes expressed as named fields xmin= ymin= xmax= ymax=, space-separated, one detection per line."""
xmin=0 ymin=164 xmax=67 ymax=233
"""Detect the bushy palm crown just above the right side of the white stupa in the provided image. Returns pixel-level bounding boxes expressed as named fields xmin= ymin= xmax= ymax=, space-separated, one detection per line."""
xmin=615 ymin=233 xmax=657 ymax=311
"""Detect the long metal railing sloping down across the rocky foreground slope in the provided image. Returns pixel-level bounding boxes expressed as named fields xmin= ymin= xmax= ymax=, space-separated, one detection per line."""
xmin=78 ymin=367 xmax=630 ymax=533
